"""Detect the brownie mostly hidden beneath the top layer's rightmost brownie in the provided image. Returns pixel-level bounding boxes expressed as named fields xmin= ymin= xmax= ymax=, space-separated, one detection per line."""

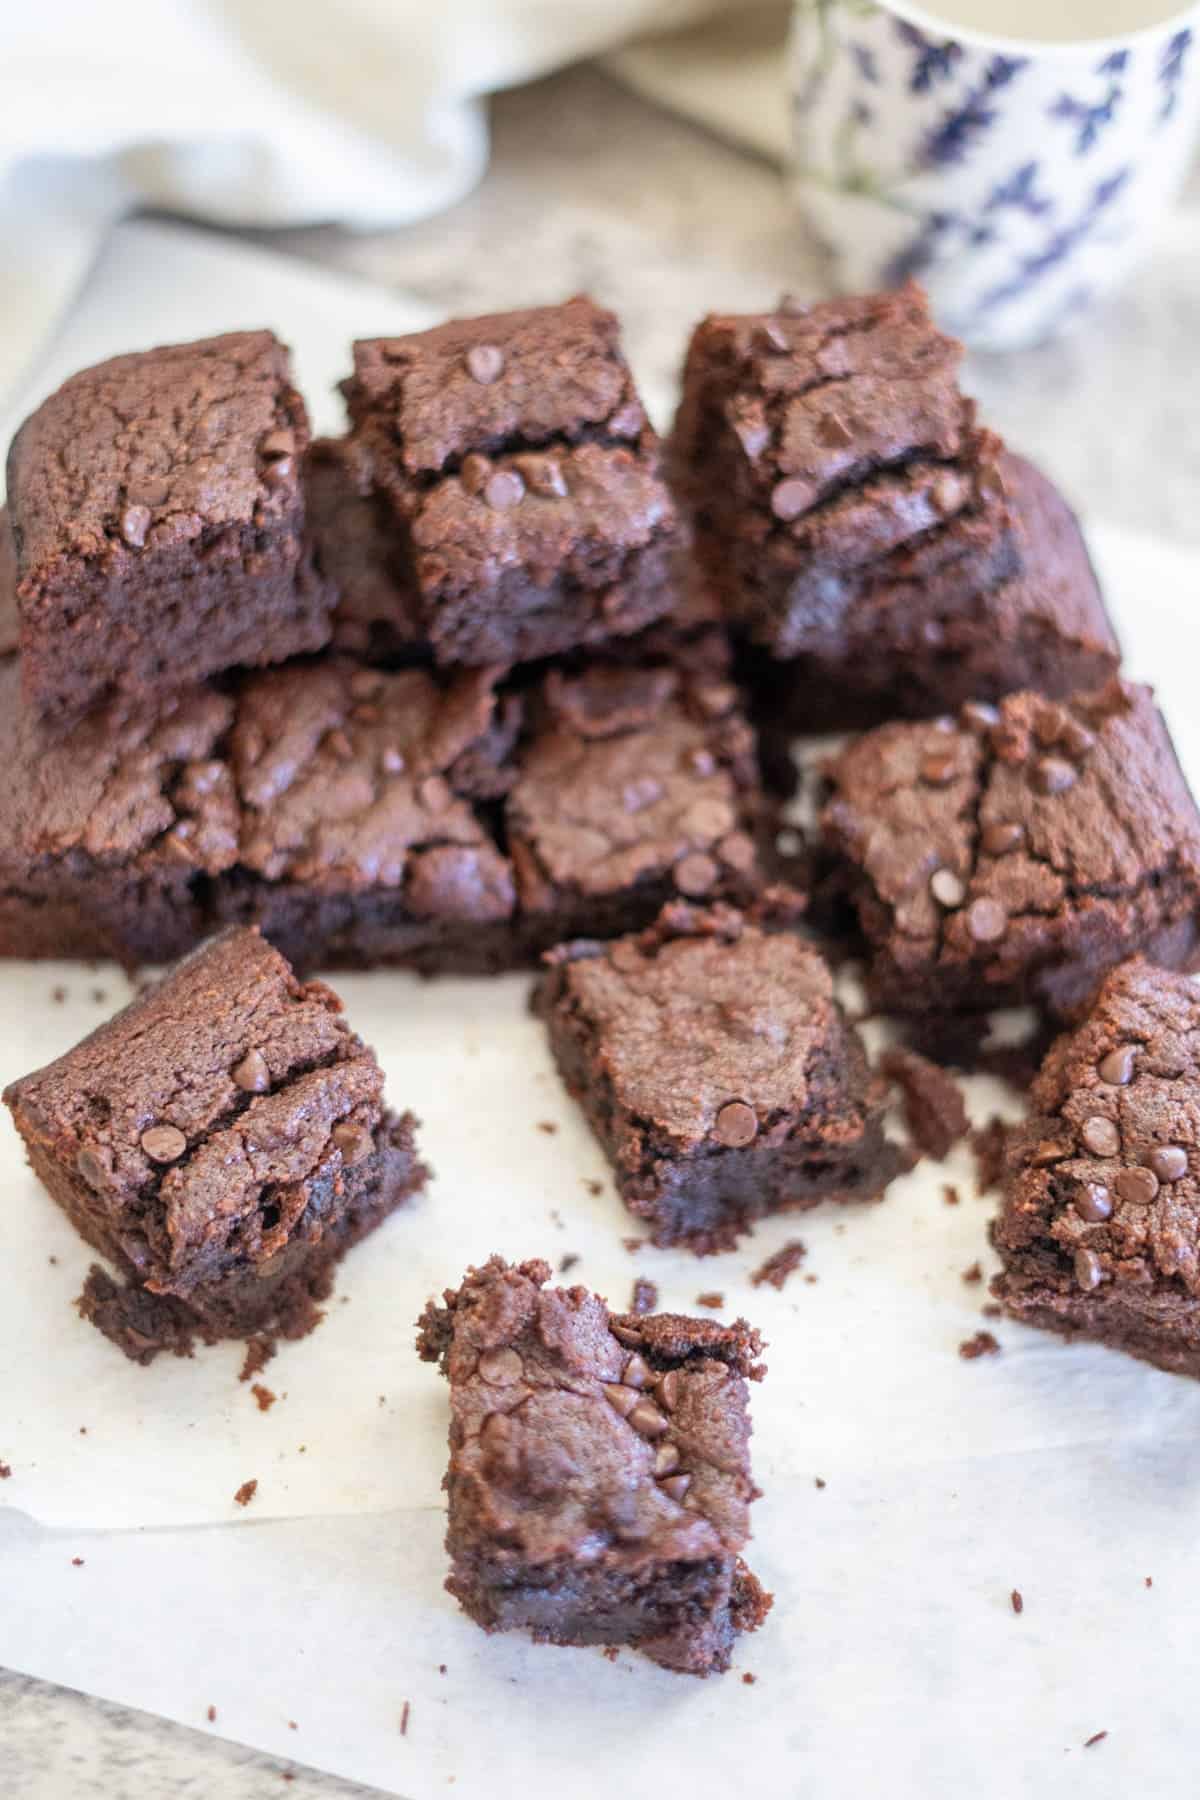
xmin=747 ymin=452 xmax=1121 ymax=734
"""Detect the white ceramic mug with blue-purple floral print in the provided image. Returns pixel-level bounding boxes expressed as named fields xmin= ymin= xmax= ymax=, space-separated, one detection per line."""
xmin=792 ymin=0 xmax=1200 ymax=349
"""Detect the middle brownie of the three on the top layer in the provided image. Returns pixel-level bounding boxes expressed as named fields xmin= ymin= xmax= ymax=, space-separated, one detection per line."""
xmin=345 ymin=299 xmax=678 ymax=664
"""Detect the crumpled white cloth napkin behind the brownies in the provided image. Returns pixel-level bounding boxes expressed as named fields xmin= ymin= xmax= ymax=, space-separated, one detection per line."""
xmin=0 ymin=0 xmax=784 ymax=394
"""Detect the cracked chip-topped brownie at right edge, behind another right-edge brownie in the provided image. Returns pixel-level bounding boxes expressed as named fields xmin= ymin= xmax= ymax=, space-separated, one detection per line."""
xmin=822 ymin=680 xmax=1200 ymax=1015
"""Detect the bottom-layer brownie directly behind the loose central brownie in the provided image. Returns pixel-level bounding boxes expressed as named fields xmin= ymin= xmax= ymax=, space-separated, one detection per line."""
xmin=507 ymin=664 xmax=766 ymax=947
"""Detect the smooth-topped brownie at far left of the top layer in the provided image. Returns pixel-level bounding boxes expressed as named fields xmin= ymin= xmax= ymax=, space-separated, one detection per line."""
xmin=9 ymin=331 xmax=333 ymax=724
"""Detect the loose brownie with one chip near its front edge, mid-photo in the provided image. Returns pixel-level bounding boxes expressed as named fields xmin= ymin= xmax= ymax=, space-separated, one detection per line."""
xmin=538 ymin=904 xmax=907 ymax=1255
